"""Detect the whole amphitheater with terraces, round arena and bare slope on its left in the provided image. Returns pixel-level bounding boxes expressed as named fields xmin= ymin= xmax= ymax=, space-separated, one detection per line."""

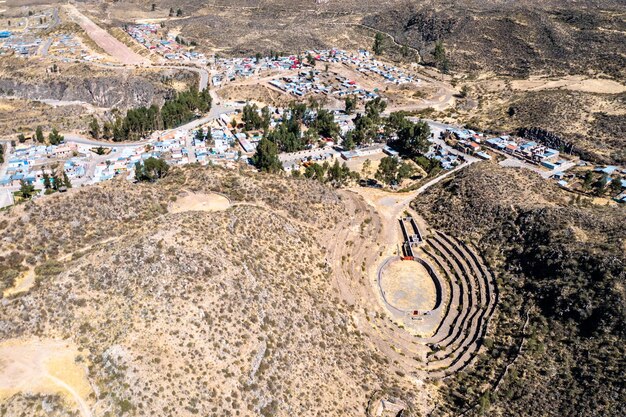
xmin=329 ymin=190 xmax=498 ymax=381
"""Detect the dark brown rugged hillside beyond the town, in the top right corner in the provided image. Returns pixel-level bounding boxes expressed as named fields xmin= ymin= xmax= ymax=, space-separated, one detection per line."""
xmin=364 ymin=0 xmax=626 ymax=78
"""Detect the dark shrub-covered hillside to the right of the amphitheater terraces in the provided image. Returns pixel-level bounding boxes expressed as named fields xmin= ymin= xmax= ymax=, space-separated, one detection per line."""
xmin=413 ymin=163 xmax=626 ymax=416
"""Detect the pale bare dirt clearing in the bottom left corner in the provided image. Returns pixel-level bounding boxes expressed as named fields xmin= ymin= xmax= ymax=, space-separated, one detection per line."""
xmin=0 ymin=339 xmax=92 ymax=417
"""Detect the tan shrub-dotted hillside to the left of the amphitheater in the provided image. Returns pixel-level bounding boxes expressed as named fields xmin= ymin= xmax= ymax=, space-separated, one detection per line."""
xmin=0 ymin=168 xmax=420 ymax=416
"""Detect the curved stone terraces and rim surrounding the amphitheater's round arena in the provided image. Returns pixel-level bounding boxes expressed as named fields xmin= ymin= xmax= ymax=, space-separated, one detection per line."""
xmin=370 ymin=214 xmax=497 ymax=379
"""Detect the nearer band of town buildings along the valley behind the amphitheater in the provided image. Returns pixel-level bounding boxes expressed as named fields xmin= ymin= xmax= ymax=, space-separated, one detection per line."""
xmin=0 ymin=92 xmax=626 ymax=206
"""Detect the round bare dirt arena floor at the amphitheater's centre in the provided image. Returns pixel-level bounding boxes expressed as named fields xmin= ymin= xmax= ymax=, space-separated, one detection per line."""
xmin=381 ymin=261 xmax=436 ymax=311
